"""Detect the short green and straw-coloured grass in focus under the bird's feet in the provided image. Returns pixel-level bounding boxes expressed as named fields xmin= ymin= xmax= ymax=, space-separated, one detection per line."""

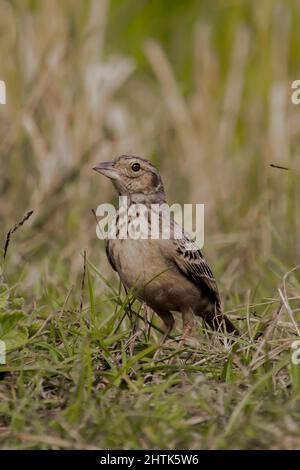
xmin=0 ymin=228 xmax=300 ymax=449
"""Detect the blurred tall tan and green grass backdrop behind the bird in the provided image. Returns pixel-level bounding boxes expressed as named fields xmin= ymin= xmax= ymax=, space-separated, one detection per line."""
xmin=0 ymin=0 xmax=300 ymax=302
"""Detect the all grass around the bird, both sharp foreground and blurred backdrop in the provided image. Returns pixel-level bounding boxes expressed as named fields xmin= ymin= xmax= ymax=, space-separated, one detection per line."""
xmin=0 ymin=0 xmax=300 ymax=449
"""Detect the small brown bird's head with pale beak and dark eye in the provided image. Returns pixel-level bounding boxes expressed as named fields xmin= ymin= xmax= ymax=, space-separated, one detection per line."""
xmin=93 ymin=155 xmax=165 ymax=203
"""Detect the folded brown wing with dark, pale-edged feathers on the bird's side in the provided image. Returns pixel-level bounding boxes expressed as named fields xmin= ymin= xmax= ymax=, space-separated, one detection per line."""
xmin=171 ymin=224 xmax=220 ymax=308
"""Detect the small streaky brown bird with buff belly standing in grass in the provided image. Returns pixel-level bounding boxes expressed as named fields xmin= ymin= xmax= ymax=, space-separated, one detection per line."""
xmin=93 ymin=155 xmax=240 ymax=352
